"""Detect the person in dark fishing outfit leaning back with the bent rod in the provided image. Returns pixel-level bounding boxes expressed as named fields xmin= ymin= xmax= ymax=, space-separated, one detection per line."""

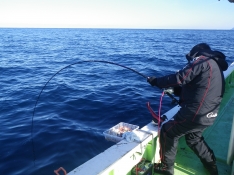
xmin=147 ymin=43 xmax=228 ymax=175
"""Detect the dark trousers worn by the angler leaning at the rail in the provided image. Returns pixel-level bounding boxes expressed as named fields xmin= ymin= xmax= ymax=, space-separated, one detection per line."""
xmin=159 ymin=116 xmax=214 ymax=167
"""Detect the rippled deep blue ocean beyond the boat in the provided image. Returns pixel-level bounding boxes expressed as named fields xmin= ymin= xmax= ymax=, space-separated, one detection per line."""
xmin=0 ymin=28 xmax=234 ymax=175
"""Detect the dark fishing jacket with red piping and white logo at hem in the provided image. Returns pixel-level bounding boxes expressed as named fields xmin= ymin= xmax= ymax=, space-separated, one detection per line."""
xmin=157 ymin=51 xmax=228 ymax=125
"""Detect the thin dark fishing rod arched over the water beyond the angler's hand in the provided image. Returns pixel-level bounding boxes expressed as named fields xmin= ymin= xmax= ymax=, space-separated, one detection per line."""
xmin=31 ymin=60 xmax=148 ymax=165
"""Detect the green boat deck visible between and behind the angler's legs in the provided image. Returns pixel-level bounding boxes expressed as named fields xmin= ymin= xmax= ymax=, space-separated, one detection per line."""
xmin=155 ymin=73 xmax=234 ymax=175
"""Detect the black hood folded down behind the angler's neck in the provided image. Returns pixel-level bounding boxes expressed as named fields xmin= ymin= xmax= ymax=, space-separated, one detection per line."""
xmin=186 ymin=50 xmax=228 ymax=71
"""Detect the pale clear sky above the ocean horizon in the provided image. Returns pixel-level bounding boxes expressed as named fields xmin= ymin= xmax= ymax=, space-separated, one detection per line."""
xmin=0 ymin=0 xmax=234 ymax=29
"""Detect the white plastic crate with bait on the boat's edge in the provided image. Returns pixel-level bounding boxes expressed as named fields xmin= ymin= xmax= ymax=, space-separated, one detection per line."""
xmin=103 ymin=122 xmax=139 ymax=142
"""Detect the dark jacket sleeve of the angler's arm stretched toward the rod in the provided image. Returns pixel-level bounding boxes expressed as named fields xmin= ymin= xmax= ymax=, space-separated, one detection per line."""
xmin=157 ymin=61 xmax=203 ymax=88
